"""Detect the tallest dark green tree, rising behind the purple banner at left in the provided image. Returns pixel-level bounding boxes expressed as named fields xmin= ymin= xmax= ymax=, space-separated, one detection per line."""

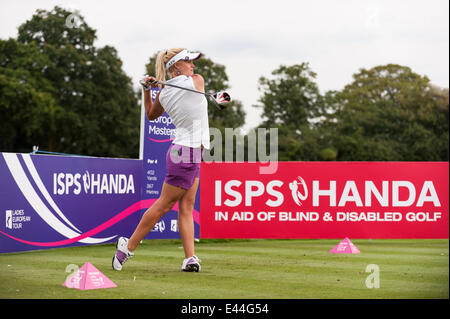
xmin=0 ymin=7 xmax=140 ymax=157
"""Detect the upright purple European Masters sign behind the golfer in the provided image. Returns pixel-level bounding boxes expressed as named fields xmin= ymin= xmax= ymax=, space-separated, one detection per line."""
xmin=140 ymin=89 xmax=200 ymax=239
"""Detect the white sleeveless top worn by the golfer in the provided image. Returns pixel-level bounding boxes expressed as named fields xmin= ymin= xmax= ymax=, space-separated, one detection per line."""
xmin=159 ymin=75 xmax=210 ymax=149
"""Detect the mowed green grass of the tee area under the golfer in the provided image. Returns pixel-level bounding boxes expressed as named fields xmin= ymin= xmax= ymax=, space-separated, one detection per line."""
xmin=0 ymin=239 xmax=449 ymax=299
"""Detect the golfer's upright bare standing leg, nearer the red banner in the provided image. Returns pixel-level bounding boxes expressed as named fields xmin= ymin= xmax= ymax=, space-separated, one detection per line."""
xmin=178 ymin=178 xmax=199 ymax=258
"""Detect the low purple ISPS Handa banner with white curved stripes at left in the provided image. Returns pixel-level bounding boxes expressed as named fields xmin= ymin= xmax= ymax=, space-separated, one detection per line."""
xmin=0 ymin=153 xmax=142 ymax=253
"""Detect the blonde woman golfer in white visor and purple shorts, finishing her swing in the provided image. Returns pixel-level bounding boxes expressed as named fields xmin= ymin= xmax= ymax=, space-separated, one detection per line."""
xmin=112 ymin=49 xmax=210 ymax=272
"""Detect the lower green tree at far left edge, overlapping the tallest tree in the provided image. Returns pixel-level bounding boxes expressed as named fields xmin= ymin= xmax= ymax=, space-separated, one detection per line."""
xmin=0 ymin=39 xmax=63 ymax=152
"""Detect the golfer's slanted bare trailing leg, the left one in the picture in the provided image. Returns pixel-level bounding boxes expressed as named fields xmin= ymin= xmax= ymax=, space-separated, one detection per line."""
xmin=128 ymin=183 xmax=187 ymax=252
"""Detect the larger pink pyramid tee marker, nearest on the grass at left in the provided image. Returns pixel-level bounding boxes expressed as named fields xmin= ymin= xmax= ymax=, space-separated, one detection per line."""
xmin=62 ymin=262 xmax=117 ymax=290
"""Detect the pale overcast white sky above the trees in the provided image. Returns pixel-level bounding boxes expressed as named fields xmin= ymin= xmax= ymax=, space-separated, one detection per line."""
xmin=0 ymin=0 xmax=449 ymax=129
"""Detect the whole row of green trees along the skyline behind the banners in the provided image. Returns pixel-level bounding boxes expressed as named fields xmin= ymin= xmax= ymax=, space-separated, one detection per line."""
xmin=0 ymin=7 xmax=449 ymax=161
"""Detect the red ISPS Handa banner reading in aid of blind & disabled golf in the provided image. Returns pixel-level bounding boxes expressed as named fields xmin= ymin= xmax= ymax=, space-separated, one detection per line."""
xmin=200 ymin=162 xmax=449 ymax=238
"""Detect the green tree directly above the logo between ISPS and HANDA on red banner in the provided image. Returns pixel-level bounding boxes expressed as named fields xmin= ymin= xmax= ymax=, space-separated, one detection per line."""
xmin=255 ymin=63 xmax=325 ymax=161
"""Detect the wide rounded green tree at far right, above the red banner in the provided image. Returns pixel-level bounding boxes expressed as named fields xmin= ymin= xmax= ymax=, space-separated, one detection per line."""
xmin=329 ymin=64 xmax=449 ymax=161
